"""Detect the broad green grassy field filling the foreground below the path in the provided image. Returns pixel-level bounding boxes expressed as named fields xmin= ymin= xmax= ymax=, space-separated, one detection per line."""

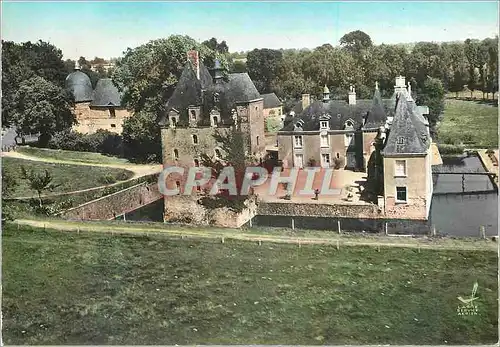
xmin=2 ymin=225 xmax=498 ymax=344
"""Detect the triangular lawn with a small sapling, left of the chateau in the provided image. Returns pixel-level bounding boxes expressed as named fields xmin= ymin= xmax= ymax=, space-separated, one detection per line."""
xmin=2 ymin=157 xmax=133 ymax=197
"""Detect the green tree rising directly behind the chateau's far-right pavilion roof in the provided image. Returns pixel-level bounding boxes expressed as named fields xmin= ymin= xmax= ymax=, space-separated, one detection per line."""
xmin=416 ymin=77 xmax=446 ymax=135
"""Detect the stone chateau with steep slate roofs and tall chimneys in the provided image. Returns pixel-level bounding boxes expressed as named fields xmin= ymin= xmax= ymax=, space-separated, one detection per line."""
xmin=160 ymin=51 xmax=435 ymax=220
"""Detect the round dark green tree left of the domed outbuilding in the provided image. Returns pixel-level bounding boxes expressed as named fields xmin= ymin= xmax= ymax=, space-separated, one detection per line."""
xmin=11 ymin=76 xmax=76 ymax=146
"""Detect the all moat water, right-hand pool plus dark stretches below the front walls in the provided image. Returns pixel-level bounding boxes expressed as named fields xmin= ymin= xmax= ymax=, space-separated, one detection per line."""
xmin=118 ymin=156 xmax=498 ymax=236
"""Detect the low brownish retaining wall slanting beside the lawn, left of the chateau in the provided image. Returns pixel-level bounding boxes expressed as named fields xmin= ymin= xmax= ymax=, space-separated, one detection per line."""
xmin=60 ymin=182 xmax=163 ymax=220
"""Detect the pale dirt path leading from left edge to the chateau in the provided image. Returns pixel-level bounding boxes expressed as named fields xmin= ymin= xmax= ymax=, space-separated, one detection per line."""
xmin=2 ymin=151 xmax=162 ymax=178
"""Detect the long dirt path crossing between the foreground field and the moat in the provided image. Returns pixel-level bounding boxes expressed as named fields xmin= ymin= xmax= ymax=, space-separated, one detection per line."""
xmin=15 ymin=219 xmax=498 ymax=251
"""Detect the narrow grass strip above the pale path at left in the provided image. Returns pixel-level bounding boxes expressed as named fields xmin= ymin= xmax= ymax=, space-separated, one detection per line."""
xmin=17 ymin=147 xmax=129 ymax=164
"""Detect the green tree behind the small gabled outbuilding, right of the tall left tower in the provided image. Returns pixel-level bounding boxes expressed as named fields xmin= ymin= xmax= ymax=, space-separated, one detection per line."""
xmin=247 ymin=48 xmax=283 ymax=93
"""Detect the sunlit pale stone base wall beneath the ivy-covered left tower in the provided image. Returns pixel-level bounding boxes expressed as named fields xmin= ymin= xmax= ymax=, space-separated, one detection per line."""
xmin=164 ymin=195 xmax=257 ymax=228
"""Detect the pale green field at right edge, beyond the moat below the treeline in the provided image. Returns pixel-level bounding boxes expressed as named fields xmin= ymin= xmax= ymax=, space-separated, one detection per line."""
xmin=438 ymin=99 xmax=498 ymax=148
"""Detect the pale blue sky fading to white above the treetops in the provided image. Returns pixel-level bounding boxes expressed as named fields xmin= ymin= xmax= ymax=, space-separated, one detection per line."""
xmin=2 ymin=0 xmax=499 ymax=59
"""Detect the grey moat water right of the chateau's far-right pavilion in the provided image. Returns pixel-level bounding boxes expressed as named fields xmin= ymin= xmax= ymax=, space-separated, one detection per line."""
xmin=430 ymin=155 xmax=498 ymax=236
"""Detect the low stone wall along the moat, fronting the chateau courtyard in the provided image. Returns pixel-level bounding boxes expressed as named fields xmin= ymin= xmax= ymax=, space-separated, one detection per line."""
xmin=257 ymin=201 xmax=383 ymax=218
